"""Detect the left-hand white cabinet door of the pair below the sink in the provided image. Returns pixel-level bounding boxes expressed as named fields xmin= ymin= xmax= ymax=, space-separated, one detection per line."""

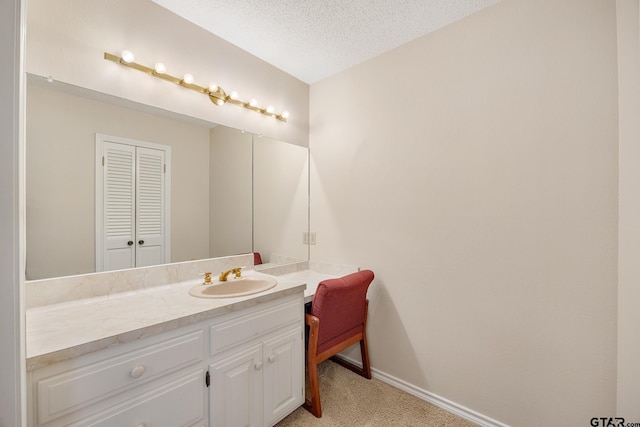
xmin=209 ymin=344 xmax=263 ymax=427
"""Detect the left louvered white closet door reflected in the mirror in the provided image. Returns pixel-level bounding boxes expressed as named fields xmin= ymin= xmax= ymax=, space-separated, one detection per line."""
xmin=102 ymin=141 xmax=136 ymax=270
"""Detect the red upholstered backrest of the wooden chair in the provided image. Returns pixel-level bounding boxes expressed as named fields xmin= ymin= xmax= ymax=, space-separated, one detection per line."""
xmin=311 ymin=270 xmax=373 ymax=347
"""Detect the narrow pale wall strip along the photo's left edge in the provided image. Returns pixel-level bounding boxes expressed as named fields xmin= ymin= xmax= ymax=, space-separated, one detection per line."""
xmin=0 ymin=0 xmax=26 ymax=426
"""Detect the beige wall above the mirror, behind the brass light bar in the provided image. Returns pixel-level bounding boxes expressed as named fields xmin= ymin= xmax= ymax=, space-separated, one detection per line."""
xmin=26 ymin=0 xmax=309 ymax=146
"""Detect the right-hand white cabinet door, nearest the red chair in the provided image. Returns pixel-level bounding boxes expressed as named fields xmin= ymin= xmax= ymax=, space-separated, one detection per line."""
xmin=263 ymin=326 xmax=304 ymax=426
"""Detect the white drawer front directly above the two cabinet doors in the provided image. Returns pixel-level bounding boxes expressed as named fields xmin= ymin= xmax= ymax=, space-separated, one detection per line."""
xmin=209 ymin=298 xmax=303 ymax=356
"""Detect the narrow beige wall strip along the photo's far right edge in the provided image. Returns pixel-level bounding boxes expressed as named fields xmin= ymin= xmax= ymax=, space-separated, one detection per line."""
xmin=616 ymin=0 xmax=640 ymax=422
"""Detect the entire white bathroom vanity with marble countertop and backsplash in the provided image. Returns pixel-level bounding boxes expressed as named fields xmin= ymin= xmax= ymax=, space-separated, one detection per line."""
xmin=26 ymin=256 xmax=350 ymax=427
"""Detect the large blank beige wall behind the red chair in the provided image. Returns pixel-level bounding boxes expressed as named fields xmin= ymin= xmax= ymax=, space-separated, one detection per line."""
xmin=310 ymin=0 xmax=618 ymax=426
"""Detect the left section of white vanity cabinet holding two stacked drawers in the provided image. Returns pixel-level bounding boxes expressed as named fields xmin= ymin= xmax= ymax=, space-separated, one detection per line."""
xmin=29 ymin=328 xmax=206 ymax=427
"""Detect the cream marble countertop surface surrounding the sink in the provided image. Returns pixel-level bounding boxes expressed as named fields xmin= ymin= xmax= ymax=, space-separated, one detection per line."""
xmin=26 ymin=270 xmax=312 ymax=370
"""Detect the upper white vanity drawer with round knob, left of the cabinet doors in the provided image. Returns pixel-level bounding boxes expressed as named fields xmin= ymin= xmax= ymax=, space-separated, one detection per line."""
xmin=35 ymin=330 xmax=204 ymax=423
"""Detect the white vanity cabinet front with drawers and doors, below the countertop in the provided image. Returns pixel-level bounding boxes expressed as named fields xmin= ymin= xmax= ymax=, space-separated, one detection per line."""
xmin=28 ymin=292 xmax=304 ymax=427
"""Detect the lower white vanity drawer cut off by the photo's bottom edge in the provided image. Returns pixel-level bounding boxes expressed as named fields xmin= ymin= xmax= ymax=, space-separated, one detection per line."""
xmin=70 ymin=369 xmax=204 ymax=427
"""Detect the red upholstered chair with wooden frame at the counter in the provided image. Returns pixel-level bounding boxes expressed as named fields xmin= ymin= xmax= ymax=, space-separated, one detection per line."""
xmin=304 ymin=270 xmax=373 ymax=418
